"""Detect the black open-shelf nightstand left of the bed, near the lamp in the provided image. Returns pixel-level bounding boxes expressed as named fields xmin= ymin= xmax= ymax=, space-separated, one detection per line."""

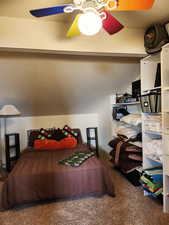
xmin=5 ymin=133 xmax=20 ymax=172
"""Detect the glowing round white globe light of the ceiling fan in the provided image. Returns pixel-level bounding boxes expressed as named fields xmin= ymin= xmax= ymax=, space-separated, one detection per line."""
xmin=78 ymin=11 xmax=102 ymax=36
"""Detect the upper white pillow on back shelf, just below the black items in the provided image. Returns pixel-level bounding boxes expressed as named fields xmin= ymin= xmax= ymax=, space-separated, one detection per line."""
xmin=120 ymin=114 xmax=142 ymax=127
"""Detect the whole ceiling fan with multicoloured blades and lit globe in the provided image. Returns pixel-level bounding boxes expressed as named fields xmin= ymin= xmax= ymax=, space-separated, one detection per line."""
xmin=30 ymin=0 xmax=155 ymax=37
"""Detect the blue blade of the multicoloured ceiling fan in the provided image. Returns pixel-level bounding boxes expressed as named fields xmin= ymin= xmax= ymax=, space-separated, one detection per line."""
xmin=30 ymin=5 xmax=70 ymax=17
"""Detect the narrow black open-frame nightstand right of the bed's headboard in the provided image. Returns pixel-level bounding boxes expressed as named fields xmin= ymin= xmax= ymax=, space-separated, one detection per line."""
xmin=86 ymin=127 xmax=99 ymax=157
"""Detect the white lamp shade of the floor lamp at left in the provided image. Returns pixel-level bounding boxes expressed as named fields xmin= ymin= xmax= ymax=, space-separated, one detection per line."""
xmin=0 ymin=105 xmax=21 ymax=117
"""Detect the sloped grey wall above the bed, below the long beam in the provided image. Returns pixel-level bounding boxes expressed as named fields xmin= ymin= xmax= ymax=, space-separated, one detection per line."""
xmin=0 ymin=53 xmax=139 ymax=116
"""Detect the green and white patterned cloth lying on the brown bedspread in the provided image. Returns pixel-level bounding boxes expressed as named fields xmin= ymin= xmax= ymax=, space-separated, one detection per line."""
xmin=58 ymin=152 xmax=95 ymax=167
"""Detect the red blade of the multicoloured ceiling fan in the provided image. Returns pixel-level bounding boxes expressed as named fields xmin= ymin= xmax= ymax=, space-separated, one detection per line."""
xmin=102 ymin=10 xmax=124 ymax=35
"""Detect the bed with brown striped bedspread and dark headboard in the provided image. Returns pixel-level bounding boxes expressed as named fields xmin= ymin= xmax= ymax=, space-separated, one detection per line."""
xmin=0 ymin=129 xmax=114 ymax=209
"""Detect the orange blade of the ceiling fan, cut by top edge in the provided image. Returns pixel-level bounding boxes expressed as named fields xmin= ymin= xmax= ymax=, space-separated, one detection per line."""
xmin=105 ymin=0 xmax=155 ymax=11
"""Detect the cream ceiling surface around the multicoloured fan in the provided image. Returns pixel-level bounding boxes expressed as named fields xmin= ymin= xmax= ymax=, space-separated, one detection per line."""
xmin=0 ymin=0 xmax=169 ymax=28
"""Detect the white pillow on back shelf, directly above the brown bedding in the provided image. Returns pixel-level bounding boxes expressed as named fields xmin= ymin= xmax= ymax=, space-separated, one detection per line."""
xmin=115 ymin=122 xmax=141 ymax=139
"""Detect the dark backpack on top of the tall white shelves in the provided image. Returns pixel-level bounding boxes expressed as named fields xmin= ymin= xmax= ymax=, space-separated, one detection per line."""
xmin=144 ymin=24 xmax=169 ymax=54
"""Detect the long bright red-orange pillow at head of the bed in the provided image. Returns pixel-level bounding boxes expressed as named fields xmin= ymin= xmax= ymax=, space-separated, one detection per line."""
xmin=34 ymin=137 xmax=77 ymax=150
